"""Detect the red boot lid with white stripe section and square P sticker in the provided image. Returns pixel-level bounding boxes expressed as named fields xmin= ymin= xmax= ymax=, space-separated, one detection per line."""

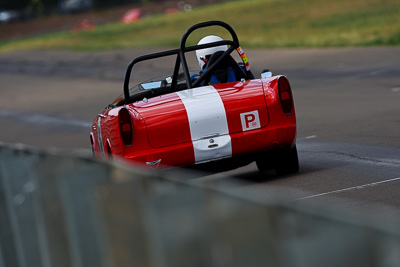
xmin=131 ymin=81 xmax=268 ymax=147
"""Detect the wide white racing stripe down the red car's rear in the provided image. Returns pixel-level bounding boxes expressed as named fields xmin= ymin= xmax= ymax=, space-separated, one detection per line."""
xmin=177 ymin=86 xmax=232 ymax=163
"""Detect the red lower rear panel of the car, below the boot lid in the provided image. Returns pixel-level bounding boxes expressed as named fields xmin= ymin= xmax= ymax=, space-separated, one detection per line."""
xmin=124 ymin=125 xmax=296 ymax=169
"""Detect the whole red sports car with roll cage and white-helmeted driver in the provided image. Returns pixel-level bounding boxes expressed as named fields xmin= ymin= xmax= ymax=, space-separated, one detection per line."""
xmin=90 ymin=21 xmax=299 ymax=174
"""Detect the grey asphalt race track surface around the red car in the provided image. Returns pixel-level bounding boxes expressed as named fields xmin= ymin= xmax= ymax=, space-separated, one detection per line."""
xmin=0 ymin=47 xmax=400 ymax=225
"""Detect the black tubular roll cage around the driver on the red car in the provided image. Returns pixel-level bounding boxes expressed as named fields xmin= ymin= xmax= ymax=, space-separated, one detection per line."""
xmin=124 ymin=20 xmax=251 ymax=104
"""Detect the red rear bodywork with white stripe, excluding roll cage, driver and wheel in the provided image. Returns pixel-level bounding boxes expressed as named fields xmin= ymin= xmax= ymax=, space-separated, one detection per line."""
xmin=92 ymin=76 xmax=296 ymax=173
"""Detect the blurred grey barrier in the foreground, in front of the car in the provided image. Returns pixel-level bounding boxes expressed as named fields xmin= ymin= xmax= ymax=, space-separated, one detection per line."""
xmin=0 ymin=141 xmax=400 ymax=267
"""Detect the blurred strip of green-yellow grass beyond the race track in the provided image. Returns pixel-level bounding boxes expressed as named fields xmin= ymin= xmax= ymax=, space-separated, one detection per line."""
xmin=0 ymin=0 xmax=400 ymax=51
